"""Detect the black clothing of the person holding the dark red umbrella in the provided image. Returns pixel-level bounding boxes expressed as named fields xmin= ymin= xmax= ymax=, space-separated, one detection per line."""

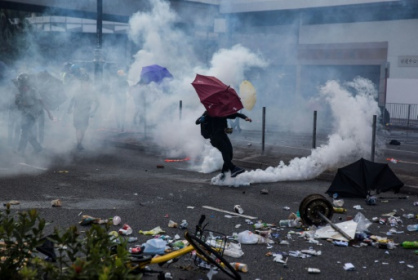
xmin=196 ymin=112 xmax=247 ymax=173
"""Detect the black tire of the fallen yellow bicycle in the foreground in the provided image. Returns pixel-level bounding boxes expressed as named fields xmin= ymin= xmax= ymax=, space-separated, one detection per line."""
xmin=184 ymin=232 xmax=241 ymax=280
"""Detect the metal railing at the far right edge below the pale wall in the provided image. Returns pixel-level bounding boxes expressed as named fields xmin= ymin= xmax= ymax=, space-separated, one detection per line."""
xmin=382 ymin=103 xmax=418 ymax=129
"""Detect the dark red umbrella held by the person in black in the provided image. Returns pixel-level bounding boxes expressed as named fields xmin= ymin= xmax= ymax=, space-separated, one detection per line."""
xmin=192 ymin=74 xmax=244 ymax=117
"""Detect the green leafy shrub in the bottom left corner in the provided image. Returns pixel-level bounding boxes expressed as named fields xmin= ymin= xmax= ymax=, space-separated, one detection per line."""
xmin=0 ymin=205 xmax=142 ymax=280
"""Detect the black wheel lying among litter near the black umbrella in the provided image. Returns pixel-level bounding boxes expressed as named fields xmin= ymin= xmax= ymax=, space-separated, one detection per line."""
xmin=299 ymin=194 xmax=334 ymax=226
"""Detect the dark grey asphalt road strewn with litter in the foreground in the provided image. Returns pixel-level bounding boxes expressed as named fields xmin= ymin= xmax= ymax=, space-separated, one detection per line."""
xmin=0 ymin=134 xmax=418 ymax=280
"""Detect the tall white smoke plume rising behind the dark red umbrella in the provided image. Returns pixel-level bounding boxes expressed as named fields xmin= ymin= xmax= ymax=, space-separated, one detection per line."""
xmin=125 ymin=1 xmax=267 ymax=162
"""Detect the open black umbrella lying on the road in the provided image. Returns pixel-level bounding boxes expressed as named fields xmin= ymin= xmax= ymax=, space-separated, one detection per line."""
xmin=326 ymin=158 xmax=404 ymax=198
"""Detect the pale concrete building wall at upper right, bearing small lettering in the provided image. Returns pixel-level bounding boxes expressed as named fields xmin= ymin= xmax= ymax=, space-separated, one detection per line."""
xmin=299 ymin=19 xmax=418 ymax=104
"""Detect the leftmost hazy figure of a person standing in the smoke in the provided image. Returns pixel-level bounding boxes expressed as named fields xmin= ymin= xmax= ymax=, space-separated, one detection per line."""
xmin=14 ymin=73 xmax=53 ymax=154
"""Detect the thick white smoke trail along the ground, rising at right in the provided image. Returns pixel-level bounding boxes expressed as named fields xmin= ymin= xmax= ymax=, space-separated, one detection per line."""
xmin=212 ymin=78 xmax=380 ymax=186
